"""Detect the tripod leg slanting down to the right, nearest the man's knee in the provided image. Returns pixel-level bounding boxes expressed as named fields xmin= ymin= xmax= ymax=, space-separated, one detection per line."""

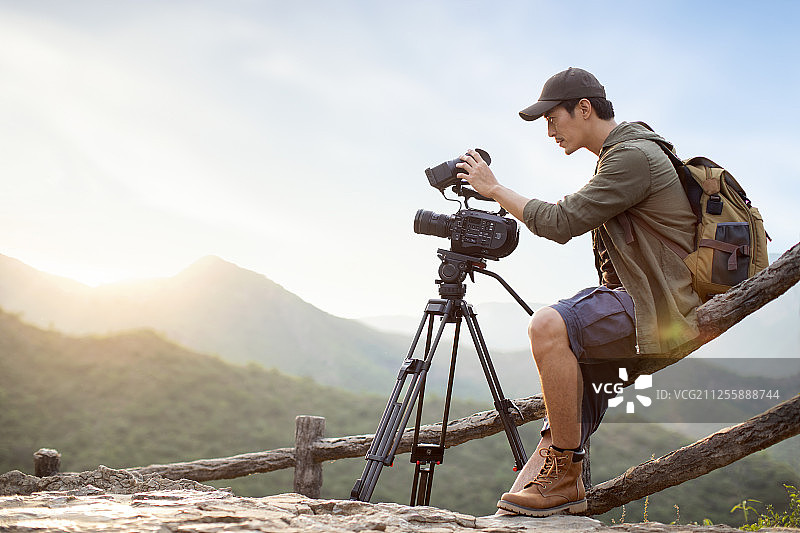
xmin=460 ymin=300 xmax=528 ymax=471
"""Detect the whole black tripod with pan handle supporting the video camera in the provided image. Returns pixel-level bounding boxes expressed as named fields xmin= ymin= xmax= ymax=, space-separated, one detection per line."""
xmin=350 ymin=249 xmax=533 ymax=505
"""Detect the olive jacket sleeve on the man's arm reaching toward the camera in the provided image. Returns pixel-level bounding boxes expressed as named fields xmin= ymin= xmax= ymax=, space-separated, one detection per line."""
xmin=523 ymin=145 xmax=651 ymax=244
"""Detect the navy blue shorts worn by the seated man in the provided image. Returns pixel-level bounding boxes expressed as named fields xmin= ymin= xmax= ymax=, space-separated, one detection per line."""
xmin=542 ymin=286 xmax=636 ymax=446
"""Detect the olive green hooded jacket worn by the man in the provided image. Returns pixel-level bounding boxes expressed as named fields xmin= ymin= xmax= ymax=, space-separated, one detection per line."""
xmin=523 ymin=122 xmax=701 ymax=354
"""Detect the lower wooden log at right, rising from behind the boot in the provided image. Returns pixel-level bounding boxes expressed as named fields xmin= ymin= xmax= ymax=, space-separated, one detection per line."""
xmin=583 ymin=395 xmax=800 ymax=515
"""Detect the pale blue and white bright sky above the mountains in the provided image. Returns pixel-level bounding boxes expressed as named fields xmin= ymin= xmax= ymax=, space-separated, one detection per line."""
xmin=0 ymin=0 xmax=800 ymax=318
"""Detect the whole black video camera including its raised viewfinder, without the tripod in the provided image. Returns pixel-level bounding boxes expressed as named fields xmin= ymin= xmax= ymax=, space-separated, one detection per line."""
xmin=414 ymin=148 xmax=519 ymax=260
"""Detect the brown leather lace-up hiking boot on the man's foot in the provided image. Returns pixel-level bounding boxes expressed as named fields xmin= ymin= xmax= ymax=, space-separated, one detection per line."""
xmin=497 ymin=446 xmax=587 ymax=516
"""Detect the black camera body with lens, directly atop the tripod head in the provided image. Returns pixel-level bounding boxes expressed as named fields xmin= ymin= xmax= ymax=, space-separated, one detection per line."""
xmin=414 ymin=209 xmax=519 ymax=259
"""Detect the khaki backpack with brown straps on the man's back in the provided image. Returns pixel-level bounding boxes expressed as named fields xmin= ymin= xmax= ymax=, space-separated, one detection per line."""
xmin=622 ymin=123 xmax=771 ymax=302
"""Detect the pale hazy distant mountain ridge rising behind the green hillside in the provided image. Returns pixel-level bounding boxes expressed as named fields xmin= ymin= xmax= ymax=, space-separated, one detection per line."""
xmin=0 ymin=255 xmax=538 ymax=399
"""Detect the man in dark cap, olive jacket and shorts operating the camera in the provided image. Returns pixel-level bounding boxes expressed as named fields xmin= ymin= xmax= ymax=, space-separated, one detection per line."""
xmin=457 ymin=68 xmax=701 ymax=516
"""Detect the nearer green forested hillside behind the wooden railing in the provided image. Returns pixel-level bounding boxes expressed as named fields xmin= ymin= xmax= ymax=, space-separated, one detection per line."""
xmin=0 ymin=312 xmax=798 ymax=525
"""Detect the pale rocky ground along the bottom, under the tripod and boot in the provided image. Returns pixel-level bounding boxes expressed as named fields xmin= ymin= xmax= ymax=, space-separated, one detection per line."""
xmin=0 ymin=467 xmax=800 ymax=533
